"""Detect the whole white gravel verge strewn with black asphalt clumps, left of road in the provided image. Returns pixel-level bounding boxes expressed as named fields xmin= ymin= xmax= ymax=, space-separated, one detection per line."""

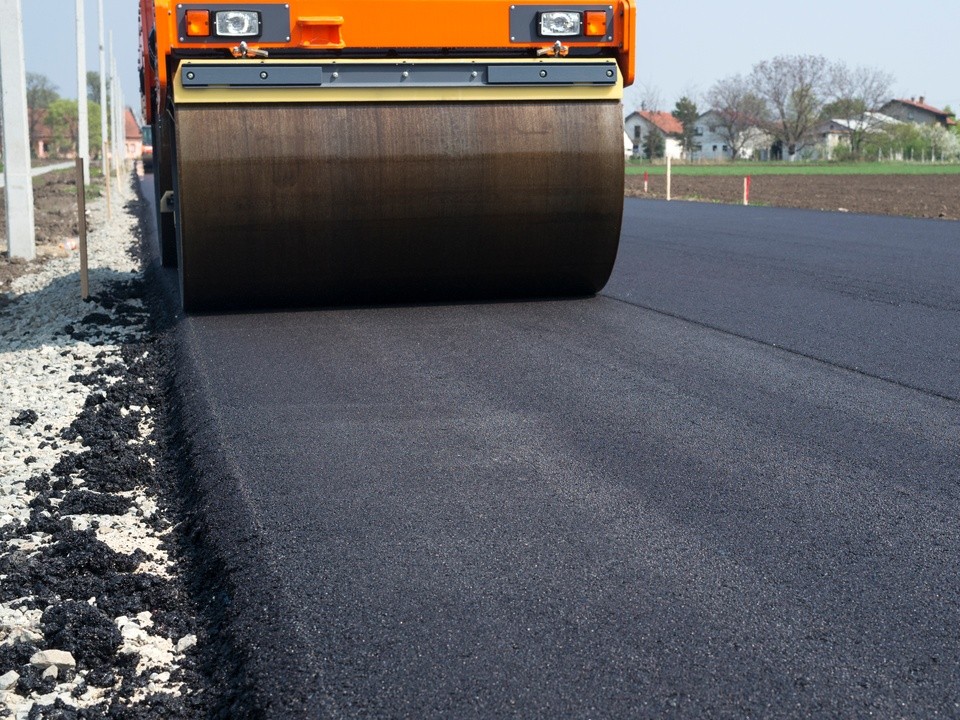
xmin=0 ymin=184 xmax=209 ymax=720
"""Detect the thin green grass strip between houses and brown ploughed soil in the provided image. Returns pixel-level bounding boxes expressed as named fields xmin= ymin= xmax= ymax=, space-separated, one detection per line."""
xmin=627 ymin=162 xmax=960 ymax=177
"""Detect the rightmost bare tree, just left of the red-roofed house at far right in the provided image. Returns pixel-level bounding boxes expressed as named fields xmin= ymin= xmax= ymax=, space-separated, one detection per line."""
xmin=823 ymin=62 xmax=893 ymax=157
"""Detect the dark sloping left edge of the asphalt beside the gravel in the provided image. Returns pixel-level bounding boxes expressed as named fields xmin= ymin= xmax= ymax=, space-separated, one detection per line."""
xmin=136 ymin=183 xmax=332 ymax=720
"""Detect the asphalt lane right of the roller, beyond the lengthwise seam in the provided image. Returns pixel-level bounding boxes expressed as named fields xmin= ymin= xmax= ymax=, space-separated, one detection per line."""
xmin=605 ymin=201 xmax=960 ymax=400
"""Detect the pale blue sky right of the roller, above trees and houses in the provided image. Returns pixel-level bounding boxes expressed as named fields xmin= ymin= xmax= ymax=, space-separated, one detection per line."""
xmin=628 ymin=0 xmax=960 ymax=112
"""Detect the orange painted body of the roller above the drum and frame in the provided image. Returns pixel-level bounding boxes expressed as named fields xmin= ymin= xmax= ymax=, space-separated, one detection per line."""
xmin=140 ymin=0 xmax=635 ymax=122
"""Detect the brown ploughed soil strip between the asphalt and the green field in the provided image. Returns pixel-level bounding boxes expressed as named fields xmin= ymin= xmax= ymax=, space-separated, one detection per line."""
xmin=626 ymin=175 xmax=960 ymax=220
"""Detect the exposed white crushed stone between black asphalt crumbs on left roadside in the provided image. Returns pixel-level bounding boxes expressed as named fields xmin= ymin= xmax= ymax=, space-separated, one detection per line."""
xmin=0 ymin=177 xmax=196 ymax=718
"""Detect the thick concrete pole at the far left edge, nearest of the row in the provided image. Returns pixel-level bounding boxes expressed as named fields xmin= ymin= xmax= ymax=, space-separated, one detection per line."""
xmin=0 ymin=0 xmax=37 ymax=260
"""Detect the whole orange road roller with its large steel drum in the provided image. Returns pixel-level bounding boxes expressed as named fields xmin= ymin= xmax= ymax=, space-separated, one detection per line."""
xmin=140 ymin=0 xmax=635 ymax=311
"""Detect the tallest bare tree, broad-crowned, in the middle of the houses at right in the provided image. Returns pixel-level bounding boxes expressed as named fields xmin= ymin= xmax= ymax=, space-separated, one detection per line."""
xmin=750 ymin=55 xmax=831 ymax=159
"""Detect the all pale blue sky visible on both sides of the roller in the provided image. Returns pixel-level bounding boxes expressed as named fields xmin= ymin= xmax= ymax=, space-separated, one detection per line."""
xmin=21 ymin=0 xmax=960 ymax=121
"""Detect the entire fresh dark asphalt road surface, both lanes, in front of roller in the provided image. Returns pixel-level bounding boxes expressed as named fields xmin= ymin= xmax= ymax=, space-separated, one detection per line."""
xmin=139 ymin=183 xmax=960 ymax=718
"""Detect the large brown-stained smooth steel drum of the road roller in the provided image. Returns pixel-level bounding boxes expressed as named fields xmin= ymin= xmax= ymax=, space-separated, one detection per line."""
xmin=175 ymin=101 xmax=624 ymax=310
